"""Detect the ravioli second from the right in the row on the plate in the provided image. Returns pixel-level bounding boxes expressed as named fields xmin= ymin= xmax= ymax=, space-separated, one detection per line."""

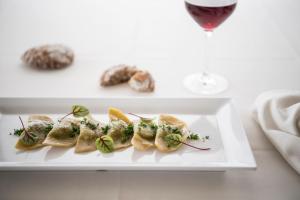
xmin=131 ymin=120 xmax=157 ymax=151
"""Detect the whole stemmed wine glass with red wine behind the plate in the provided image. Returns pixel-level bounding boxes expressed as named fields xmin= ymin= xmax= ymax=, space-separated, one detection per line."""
xmin=183 ymin=0 xmax=237 ymax=95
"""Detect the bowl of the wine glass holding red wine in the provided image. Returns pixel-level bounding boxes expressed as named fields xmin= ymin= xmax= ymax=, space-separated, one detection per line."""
xmin=185 ymin=0 xmax=236 ymax=31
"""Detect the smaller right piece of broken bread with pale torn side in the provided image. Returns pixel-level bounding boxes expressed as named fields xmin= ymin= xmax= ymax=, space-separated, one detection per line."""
xmin=128 ymin=71 xmax=155 ymax=92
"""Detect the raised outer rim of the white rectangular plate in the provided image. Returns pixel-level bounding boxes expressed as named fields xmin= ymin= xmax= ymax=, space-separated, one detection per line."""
xmin=0 ymin=96 xmax=257 ymax=171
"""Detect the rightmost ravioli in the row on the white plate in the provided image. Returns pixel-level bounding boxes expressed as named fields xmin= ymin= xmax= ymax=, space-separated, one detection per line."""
xmin=155 ymin=115 xmax=188 ymax=152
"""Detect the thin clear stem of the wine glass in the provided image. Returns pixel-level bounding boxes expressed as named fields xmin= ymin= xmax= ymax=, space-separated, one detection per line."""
xmin=202 ymin=30 xmax=212 ymax=78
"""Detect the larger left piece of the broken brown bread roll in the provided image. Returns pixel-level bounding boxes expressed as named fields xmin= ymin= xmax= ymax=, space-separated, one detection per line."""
xmin=100 ymin=64 xmax=138 ymax=86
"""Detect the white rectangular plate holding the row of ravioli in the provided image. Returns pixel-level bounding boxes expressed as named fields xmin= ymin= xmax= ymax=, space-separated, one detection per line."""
xmin=0 ymin=98 xmax=256 ymax=171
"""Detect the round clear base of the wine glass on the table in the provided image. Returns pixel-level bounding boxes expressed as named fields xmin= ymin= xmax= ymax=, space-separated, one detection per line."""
xmin=183 ymin=73 xmax=228 ymax=95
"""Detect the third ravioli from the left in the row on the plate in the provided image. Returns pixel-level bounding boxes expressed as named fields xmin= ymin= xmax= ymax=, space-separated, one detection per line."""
xmin=75 ymin=118 xmax=103 ymax=153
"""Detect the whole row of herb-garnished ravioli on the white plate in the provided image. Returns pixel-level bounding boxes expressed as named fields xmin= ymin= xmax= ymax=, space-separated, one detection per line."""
xmin=14 ymin=105 xmax=209 ymax=153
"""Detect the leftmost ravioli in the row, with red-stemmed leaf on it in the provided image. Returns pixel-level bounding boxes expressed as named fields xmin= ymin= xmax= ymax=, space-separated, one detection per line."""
xmin=15 ymin=115 xmax=53 ymax=150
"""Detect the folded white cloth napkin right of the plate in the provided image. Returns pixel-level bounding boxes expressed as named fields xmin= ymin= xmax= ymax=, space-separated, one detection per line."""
xmin=253 ymin=90 xmax=300 ymax=174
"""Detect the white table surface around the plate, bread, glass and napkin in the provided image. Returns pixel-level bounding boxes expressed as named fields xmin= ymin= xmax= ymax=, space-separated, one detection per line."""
xmin=0 ymin=0 xmax=300 ymax=200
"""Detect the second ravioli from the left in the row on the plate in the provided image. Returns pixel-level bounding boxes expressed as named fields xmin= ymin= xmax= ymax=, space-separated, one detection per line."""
xmin=43 ymin=118 xmax=80 ymax=147
